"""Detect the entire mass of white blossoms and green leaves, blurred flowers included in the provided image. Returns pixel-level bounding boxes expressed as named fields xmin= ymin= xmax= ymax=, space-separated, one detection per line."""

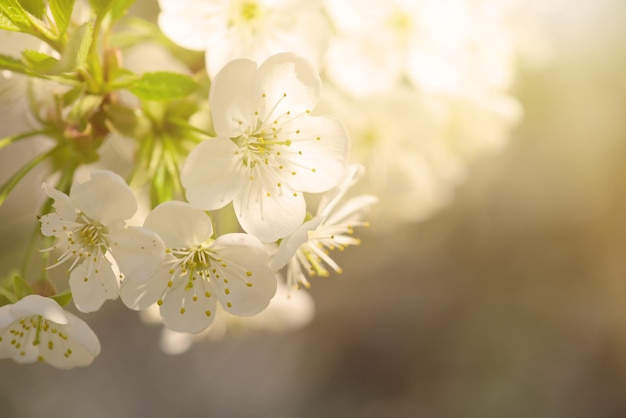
xmin=0 ymin=0 xmax=540 ymax=368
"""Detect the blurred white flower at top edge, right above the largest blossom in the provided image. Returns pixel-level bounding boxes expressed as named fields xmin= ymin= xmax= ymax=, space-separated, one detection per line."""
xmin=159 ymin=0 xmax=328 ymax=77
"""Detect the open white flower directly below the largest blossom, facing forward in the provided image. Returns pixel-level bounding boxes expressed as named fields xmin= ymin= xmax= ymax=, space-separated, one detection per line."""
xmin=121 ymin=201 xmax=277 ymax=333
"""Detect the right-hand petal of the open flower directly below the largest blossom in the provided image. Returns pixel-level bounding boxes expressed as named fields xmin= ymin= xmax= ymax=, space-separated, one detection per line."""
xmin=212 ymin=234 xmax=277 ymax=316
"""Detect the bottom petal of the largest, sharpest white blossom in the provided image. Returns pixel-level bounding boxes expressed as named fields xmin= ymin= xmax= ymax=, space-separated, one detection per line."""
xmin=233 ymin=182 xmax=306 ymax=242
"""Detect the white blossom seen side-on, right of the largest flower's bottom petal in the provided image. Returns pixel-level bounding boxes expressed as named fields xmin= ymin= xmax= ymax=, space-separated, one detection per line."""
xmin=271 ymin=164 xmax=378 ymax=288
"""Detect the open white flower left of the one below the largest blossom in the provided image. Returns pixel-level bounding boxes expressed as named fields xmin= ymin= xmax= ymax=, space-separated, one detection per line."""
xmin=41 ymin=171 xmax=164 ymax=312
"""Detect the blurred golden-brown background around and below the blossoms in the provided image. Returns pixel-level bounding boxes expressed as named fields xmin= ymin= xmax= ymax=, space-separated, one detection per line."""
xmin=0 ymin=0 xmax=626 ymax=418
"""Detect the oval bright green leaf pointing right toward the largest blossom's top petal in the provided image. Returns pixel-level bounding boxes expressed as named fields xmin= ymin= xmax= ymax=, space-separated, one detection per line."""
xmin=129 ymin=71 xmax=199 ymax=100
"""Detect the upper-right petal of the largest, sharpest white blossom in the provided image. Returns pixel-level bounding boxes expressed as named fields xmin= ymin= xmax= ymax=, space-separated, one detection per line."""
xmin=258 ymin=53 xmax=321 ymax=123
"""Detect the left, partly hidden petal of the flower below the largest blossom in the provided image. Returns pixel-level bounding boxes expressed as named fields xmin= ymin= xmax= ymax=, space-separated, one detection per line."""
xmin=120 ymin=265 xmax=171 ymax=311
